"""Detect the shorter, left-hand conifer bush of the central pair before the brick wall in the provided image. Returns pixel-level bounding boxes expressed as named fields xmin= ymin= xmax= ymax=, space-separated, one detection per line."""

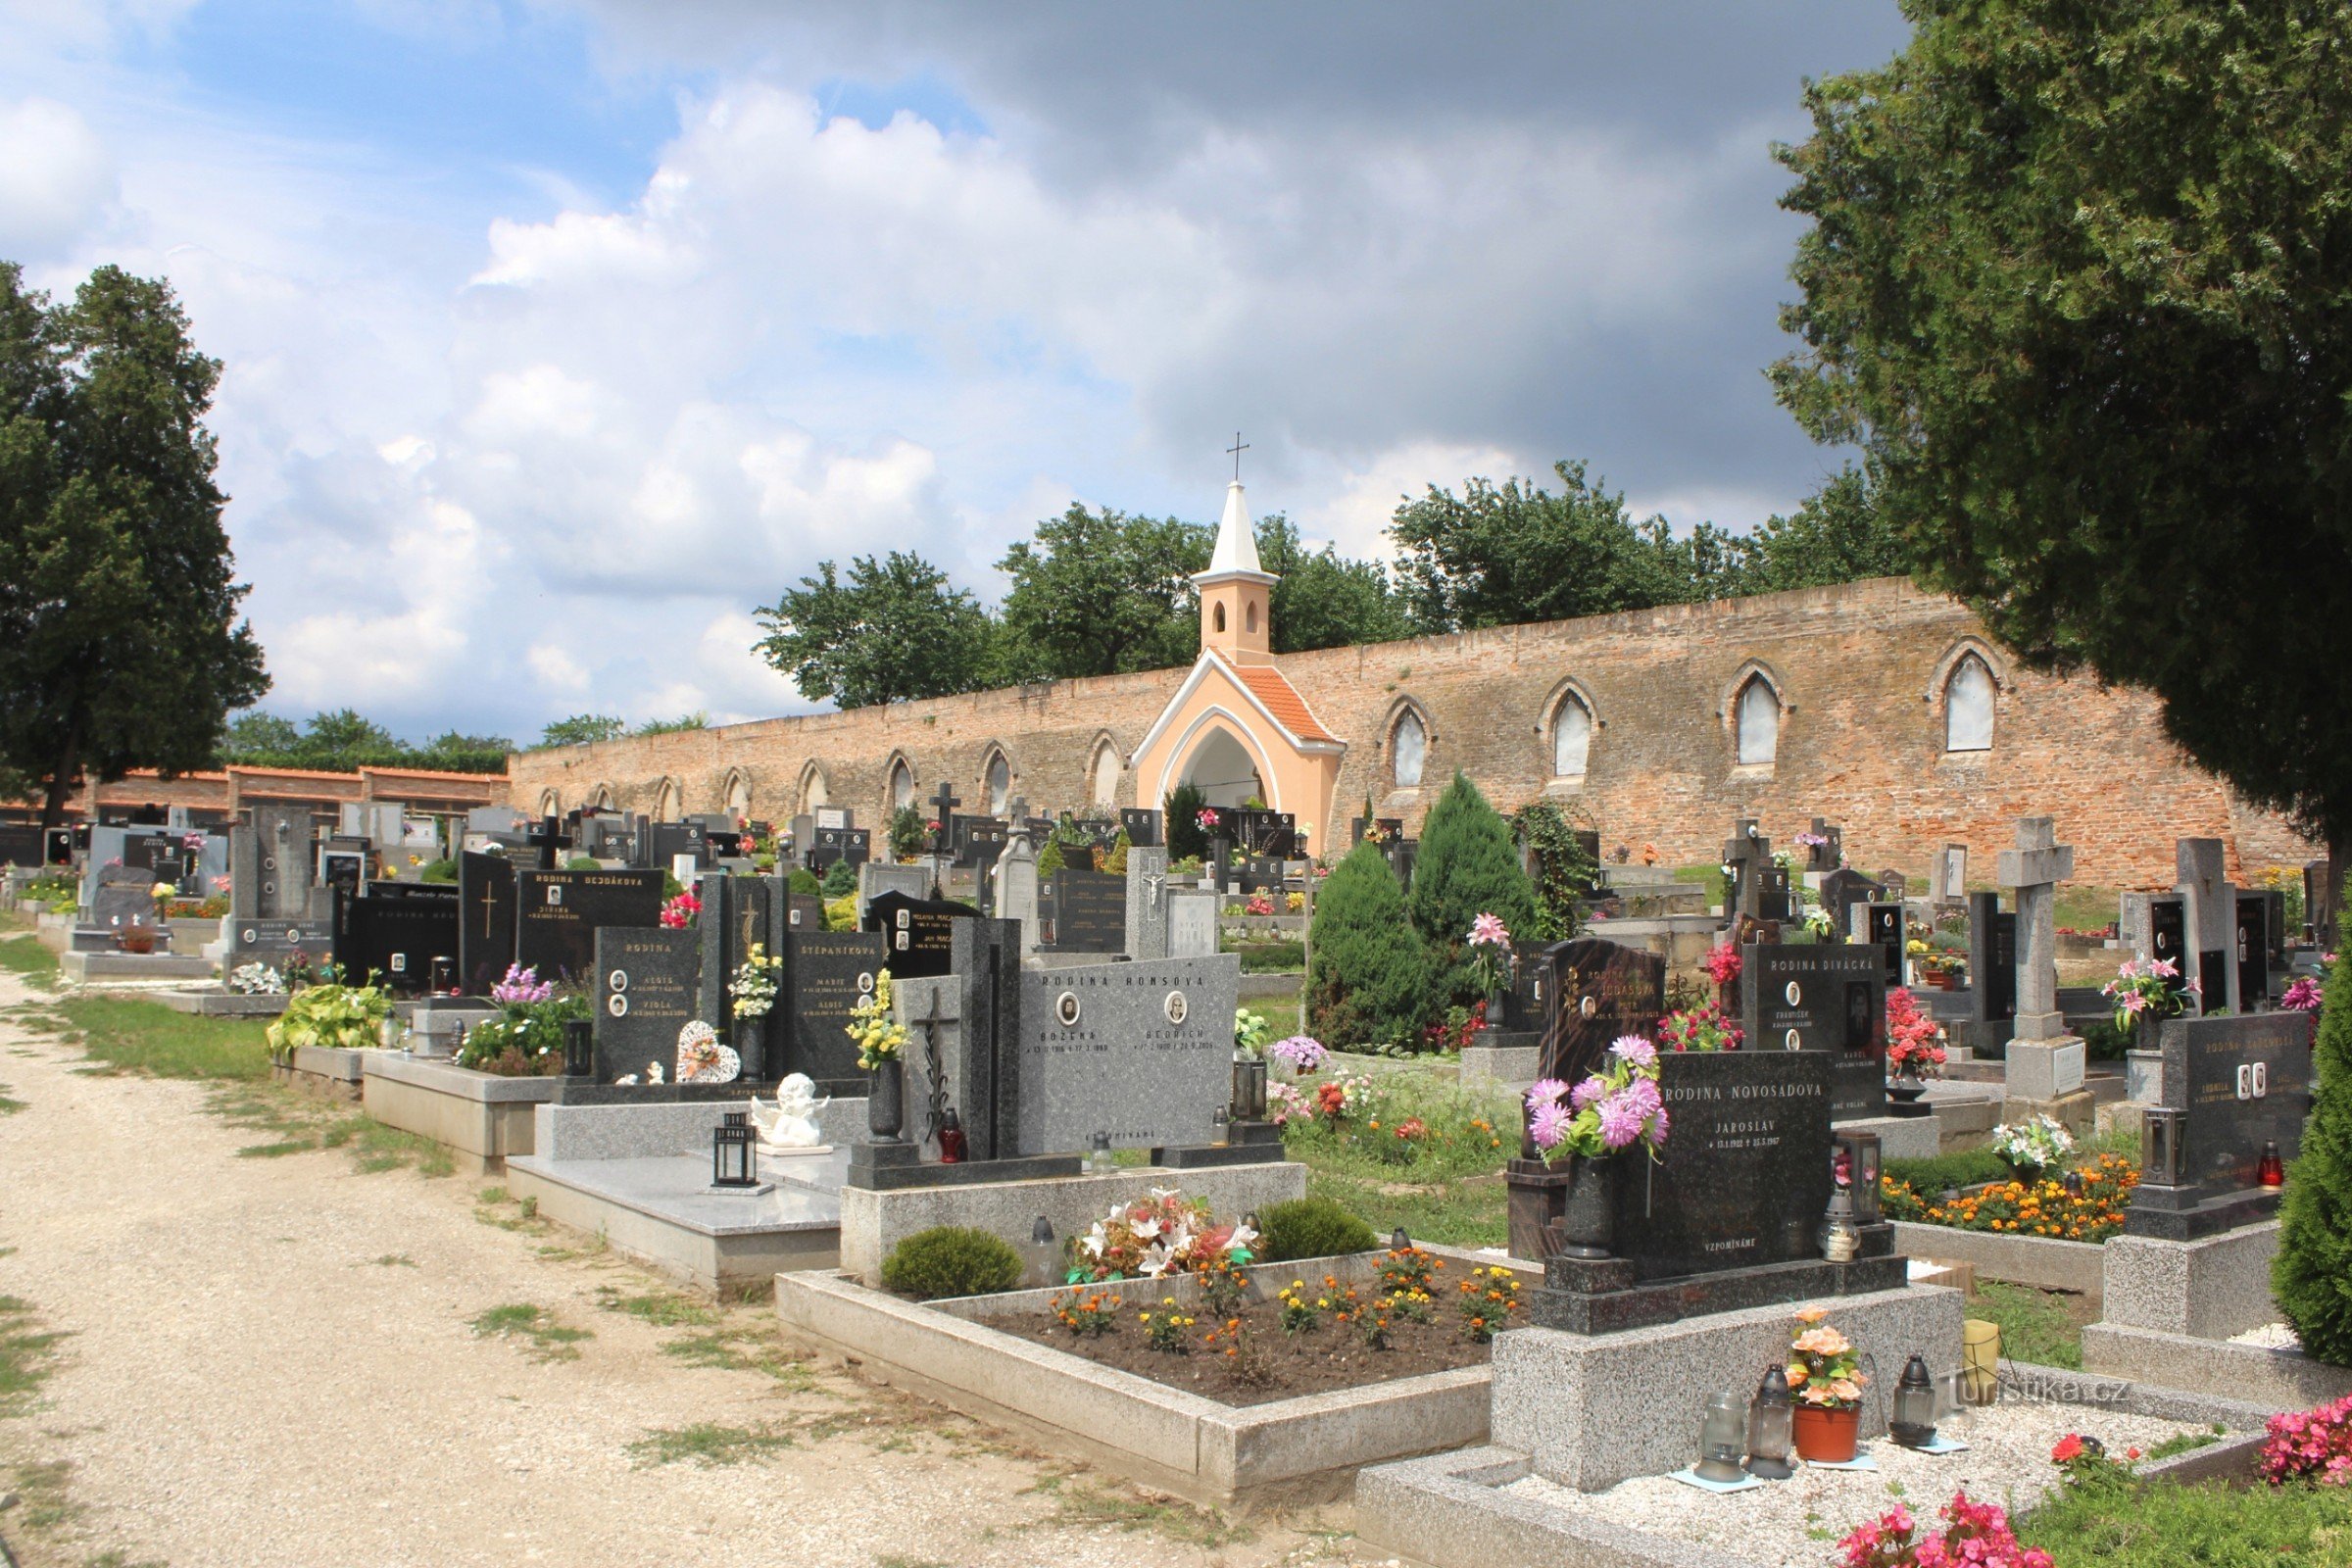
xmin=1307 ymin=839 xmax=1430 ymax=1046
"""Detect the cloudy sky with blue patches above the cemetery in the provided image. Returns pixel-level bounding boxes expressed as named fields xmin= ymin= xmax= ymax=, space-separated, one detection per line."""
xmin=0 ymin=0 xmax=1903 ymax=741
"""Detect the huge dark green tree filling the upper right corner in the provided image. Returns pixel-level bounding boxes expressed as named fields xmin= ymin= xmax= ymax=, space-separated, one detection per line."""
xmin=1774 ymin=0 xmax=2352 ymax=886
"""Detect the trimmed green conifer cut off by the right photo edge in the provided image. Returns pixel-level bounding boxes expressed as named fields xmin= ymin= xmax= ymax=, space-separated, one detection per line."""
xmin=2270 ymin=896 xmax=2352 ymax=1366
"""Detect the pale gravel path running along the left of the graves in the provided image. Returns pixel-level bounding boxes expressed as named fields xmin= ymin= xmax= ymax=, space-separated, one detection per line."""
xmin=0 ymin=976 xmax=1381 ymax=1568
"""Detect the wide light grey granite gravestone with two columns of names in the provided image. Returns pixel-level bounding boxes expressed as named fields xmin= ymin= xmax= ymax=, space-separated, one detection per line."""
xmin=998 ymin=955 xmax=1242 ymax=1154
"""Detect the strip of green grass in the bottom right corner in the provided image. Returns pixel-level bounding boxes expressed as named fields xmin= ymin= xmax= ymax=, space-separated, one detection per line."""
xmin=2016 ymin=1476 xmax=2352 ymax=1568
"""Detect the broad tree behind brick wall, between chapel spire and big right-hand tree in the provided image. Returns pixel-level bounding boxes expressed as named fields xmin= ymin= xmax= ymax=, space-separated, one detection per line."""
xmin=1388 ymin=459 xmax=1740 ymax=632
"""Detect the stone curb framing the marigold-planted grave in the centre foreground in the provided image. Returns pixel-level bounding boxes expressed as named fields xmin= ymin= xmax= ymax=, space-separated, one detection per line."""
xmin=776 ymin=1249 xmax=1498 ymax=1507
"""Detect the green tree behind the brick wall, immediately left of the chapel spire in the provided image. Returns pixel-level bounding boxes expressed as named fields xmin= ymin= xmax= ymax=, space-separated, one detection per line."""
xmin=998 ymin=501 xmax=1216 ymax=679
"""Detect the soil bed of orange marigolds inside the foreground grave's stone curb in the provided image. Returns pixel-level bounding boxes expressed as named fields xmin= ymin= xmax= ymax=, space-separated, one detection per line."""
xmin=995 ymin=1246 xmax=1541 ymax=1405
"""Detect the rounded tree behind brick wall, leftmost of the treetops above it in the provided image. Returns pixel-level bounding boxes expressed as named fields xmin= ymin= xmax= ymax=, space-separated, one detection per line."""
xmin=753 ymin=550 xmax=1002 ymax=708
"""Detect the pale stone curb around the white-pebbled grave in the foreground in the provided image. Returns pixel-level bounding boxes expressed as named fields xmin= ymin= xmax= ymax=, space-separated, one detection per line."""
xmin=1354 ymin=1363 xmax=2270 ymax=1568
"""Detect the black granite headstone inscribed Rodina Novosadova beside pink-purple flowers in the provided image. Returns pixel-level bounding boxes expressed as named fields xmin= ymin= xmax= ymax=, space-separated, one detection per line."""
xmin=1609 ymin=1048 xmax=1835 ymax=1279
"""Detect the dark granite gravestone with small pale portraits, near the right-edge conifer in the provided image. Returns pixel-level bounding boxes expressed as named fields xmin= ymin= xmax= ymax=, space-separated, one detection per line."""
xmin=2124 ymin=1010 xmax=2312 ymax=1239
